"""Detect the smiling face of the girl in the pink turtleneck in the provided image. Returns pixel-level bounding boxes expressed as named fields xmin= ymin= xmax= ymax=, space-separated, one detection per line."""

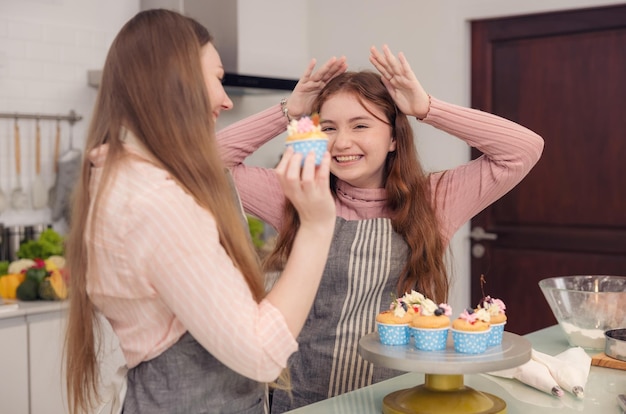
xmin=320 ymin=92 xmax=396 ymax=188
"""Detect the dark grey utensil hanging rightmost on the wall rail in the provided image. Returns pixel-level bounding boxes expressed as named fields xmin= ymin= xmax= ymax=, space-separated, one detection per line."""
xmin=50 ymin=120 xmax=82 ymax=223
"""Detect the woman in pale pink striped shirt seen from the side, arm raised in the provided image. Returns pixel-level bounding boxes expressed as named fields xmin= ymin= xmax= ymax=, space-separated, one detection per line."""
xmin=65 ymin=10 xmax=345 ymax=414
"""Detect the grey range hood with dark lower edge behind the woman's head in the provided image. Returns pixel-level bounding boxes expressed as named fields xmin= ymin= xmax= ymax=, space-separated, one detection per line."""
xmin=87 ymin=0 xmax=298 ymax=95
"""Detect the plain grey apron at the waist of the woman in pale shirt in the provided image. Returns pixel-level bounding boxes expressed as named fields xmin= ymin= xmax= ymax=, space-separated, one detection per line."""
xmin=122 ymin=333 xmax=267 ymax=414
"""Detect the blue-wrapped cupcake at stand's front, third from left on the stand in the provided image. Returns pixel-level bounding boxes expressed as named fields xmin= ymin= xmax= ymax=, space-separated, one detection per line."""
xmin=452 ymin=308 xmax=491 ymax=354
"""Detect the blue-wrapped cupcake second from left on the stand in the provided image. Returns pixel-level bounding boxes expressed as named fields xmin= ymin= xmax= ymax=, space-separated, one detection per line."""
xmin=410 ymin=298 xmax=452 ymax=351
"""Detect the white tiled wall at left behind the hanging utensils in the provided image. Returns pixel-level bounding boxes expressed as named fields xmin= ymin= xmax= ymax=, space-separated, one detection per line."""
xmin=0 ymin=0 xmax=139 ymax=231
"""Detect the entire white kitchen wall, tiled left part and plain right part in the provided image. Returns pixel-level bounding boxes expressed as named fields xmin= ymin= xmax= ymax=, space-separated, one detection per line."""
xmin=0 ymin=0 xmax=624 ymax=309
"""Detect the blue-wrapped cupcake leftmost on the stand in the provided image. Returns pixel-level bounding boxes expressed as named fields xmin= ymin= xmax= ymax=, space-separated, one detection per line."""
xmin=376 ymin=298 xmax=415 ymax=345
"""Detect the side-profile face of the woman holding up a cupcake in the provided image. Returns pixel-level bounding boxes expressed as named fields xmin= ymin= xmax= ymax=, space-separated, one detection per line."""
xmin=200 ymin=42 xmax=233 ymax=120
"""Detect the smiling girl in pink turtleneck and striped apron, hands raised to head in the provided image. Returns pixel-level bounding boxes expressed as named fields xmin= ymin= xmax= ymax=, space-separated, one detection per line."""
xmin=218 ymin=46 xmax=543 ymax=413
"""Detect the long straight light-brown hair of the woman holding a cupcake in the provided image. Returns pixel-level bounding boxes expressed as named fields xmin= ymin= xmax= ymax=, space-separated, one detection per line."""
xmin=65 ymin=10 xmax=264 ymax=413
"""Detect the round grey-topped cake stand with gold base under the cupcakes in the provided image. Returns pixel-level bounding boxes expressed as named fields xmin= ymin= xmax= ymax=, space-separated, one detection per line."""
xmin=359 ymin=332 xmax=532 ymax=414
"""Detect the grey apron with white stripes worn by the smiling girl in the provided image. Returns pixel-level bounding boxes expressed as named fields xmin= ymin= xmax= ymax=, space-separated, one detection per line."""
xmin=271 ymin=218 xmax=408 ymax=414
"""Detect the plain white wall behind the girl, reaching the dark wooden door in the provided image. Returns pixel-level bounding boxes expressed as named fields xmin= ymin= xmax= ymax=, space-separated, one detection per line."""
xmin=230 ymin=0 xmax=625 ymax=310
